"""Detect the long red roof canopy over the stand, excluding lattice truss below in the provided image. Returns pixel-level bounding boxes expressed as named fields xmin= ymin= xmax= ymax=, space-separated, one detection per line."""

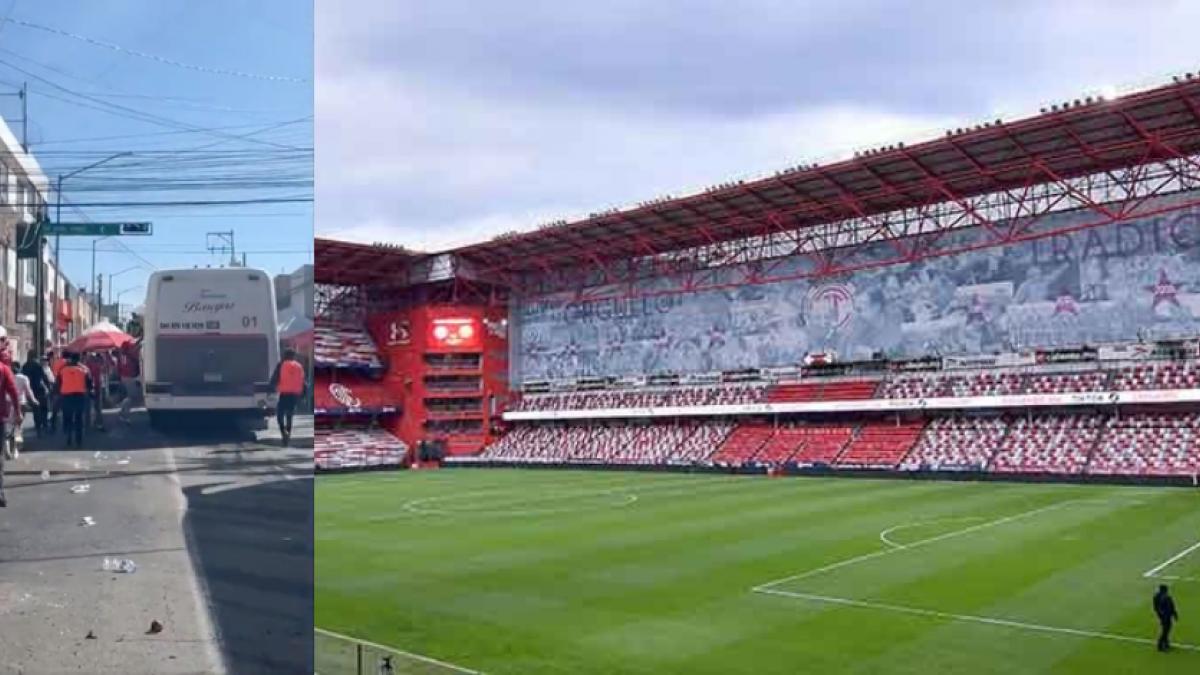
xmin=452 ymin=76 xmax=1200 ymax=275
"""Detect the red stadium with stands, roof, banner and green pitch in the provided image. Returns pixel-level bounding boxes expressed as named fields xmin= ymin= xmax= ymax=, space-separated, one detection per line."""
xmin=314 ymin=74 xmax=1200 ymax=674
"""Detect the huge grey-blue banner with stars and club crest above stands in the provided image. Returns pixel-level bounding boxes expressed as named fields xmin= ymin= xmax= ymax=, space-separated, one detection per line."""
xmin=514 ymin=193 xmax=1200 ymax=380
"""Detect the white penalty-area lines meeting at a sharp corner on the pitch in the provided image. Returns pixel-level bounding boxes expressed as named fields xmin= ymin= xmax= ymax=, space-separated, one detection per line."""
xmin=750 ymin=500 xmax=1200 ymax=652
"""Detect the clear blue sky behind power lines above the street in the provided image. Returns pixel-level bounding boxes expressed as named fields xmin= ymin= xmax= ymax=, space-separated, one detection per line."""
xmin=0 ymin=0 xmax=313 ymax=305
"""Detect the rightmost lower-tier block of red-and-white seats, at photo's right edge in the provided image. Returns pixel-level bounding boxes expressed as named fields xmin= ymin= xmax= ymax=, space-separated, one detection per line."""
xmin=1087 ymin=413 xmax=1200 ymax=476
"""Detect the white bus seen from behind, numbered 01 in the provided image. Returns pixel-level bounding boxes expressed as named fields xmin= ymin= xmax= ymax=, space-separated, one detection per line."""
xmin=142 ymin=268 xmax=280 ymax=429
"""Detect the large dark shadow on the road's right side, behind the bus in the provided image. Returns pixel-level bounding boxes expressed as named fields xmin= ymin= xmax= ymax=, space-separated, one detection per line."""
xmin=184 ymin=477 xmax=313 ymax=674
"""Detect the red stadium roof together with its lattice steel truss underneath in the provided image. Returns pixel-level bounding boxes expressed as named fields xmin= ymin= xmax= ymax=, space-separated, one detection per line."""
xmin=450 ymin=79 xmax=1200 ymax=299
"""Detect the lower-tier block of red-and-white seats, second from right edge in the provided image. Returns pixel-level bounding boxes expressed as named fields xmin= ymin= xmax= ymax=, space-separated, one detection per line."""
xmin=991 ymin=414 xmax=1102 ymax=474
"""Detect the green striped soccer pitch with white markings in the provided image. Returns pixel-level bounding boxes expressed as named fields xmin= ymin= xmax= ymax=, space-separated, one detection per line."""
xmin=316 ymin=470 xmax=1200 ymax=675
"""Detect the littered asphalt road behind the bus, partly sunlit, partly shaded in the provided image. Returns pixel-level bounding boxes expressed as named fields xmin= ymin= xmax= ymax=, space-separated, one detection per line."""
xmin=0 ymin=414 xmax=313 ymax=674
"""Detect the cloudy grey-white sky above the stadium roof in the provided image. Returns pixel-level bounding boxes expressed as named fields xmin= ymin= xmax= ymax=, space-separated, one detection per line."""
xmin=316 ymin=0 xmax=1200 ymax=250
